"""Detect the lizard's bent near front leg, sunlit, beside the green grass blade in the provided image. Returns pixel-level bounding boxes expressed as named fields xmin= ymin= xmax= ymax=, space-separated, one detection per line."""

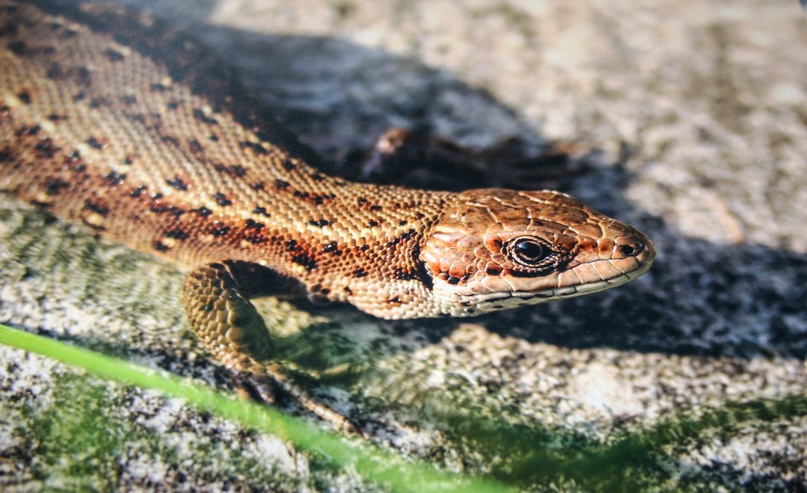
xmin=183 ymin=261 xmax=358 ymax=432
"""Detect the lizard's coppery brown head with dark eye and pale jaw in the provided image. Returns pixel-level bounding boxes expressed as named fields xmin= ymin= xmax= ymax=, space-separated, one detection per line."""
xmin=420 ymin=189 xmax=655 ymax=316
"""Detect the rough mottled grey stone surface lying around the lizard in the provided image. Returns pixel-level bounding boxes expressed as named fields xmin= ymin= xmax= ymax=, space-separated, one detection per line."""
xmin=0 ymin=0 xmax=807 ymax=491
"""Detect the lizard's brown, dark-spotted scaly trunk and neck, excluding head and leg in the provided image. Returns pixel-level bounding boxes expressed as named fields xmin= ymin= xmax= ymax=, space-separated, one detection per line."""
xmin=0 ymin=2 xmax=448 ymax=318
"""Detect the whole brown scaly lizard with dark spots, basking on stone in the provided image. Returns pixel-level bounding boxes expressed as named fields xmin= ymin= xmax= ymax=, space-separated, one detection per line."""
xmin=0 ymin=1 xmax=655 ymax=430
